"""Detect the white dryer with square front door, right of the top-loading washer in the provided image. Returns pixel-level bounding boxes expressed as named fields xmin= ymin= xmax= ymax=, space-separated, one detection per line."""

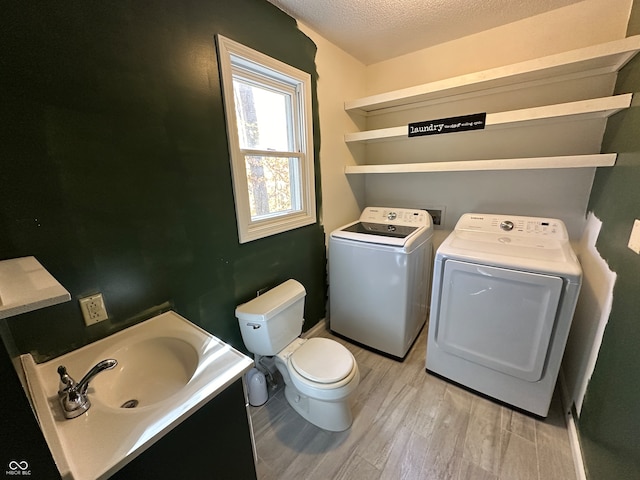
xmin=426 ymin=213 xmax=582 ymax=417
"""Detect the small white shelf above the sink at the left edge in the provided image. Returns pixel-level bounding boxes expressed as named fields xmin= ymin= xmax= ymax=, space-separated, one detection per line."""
xmin=0 ymin=257 xmax=71 ymax=318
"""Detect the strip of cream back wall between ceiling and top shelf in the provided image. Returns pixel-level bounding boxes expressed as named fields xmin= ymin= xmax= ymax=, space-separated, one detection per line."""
xmin=362 ymin=0 xmax=632 ymax=99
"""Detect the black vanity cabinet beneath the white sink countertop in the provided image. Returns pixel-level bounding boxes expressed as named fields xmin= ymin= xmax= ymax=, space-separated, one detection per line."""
xmin=111 ymin=379 xmax=257 ymax=480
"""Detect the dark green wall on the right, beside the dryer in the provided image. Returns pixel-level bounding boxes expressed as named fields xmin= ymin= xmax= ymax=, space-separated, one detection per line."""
xmin=578 ymin=0 xmax=640 ymax=480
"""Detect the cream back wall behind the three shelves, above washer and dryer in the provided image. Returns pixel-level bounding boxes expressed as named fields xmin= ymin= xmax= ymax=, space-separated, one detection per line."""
xmin=358 ymin=0 xmax=631 ymax=241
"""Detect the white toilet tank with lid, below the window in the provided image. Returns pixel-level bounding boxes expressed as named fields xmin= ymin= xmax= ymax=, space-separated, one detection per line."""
xmin=236 ymin=280 xmax=306 ymax=356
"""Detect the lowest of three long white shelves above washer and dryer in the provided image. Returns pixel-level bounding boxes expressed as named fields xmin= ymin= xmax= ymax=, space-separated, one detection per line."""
xmin=345 ymin=153 xmax=617 ymax=175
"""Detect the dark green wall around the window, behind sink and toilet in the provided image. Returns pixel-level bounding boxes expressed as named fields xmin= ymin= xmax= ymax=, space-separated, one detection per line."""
xmin=0 ymin=0 xmax=326 ymax=360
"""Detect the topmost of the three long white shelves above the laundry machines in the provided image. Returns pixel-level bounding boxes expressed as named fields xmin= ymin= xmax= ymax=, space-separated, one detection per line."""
xmin=345 ymin=35 xmax=640 ymax=114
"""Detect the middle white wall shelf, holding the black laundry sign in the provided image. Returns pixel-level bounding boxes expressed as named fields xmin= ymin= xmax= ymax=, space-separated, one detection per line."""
xmin=344 ymin=93 xmax=633 ymax=143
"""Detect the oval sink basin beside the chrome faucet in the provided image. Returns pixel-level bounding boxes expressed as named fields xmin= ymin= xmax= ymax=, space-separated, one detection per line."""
xmin=89 ymin=337 xmax=198 ymax=408
